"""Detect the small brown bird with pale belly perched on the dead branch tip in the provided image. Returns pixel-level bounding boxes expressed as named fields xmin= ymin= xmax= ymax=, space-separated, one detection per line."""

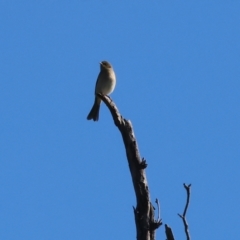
xmin=87 ymin=61 xmax=116 ymax=121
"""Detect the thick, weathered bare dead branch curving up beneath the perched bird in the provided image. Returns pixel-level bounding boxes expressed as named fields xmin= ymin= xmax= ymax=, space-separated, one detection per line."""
xmin=99 ymin=94 xmax=162 ymax=240
